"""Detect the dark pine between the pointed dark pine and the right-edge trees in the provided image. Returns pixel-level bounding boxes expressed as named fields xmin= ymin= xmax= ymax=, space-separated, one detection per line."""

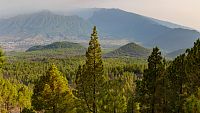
xmin=167 ymin=54 xmax=188 ymax=113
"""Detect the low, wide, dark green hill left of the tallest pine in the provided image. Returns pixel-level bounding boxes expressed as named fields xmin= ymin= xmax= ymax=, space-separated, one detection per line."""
xmin=27 ymin=41 xmax=85 ymax=52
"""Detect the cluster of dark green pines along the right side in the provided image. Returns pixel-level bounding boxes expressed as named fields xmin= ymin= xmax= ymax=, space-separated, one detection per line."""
xmin=137 ymin=39 xmax=200 ymax=113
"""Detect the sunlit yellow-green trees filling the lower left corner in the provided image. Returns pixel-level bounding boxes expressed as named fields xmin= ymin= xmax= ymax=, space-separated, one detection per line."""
xmin=0 ymin=50 xmax=32 ymax=113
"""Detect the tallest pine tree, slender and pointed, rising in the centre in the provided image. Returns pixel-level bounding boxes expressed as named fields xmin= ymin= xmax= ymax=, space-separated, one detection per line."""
xmin=74 ymin=27 xmax=104 ymax=113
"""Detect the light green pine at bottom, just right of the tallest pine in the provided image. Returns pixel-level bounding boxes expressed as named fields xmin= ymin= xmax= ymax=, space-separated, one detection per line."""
xmin=100 ymin=74 xmax=128 ymax=113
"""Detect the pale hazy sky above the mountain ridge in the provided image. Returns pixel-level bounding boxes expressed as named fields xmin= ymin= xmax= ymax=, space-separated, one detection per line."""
xmin=0 ymin=0 xmax=200 ymax=30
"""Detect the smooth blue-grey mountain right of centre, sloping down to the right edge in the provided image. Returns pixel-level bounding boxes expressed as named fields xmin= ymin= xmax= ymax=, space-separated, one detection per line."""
xmin=89 ymin=9 xmax=200 ymax=52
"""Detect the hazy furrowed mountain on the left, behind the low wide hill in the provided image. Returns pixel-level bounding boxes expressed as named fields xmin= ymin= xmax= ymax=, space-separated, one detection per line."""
xmin=0 ymin=11 xmax=92 ymax=38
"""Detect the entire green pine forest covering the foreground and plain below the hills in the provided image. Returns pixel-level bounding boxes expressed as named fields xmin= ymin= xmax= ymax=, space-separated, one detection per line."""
xmin=0 ymin=27 xmax=200 ymax=113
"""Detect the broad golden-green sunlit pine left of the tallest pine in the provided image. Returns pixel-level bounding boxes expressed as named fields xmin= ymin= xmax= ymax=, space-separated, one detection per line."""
xmin=32 ymin=65 xmax=73 ymax=113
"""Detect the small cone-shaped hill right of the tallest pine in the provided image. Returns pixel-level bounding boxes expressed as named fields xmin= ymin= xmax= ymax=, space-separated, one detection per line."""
xmin=104 ymin=43 xmax=150 ymax=58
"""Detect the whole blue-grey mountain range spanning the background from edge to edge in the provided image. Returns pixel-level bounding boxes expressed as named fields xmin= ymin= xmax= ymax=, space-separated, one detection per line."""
xmin=0 ymin=8 xmax=200 ymax=52
